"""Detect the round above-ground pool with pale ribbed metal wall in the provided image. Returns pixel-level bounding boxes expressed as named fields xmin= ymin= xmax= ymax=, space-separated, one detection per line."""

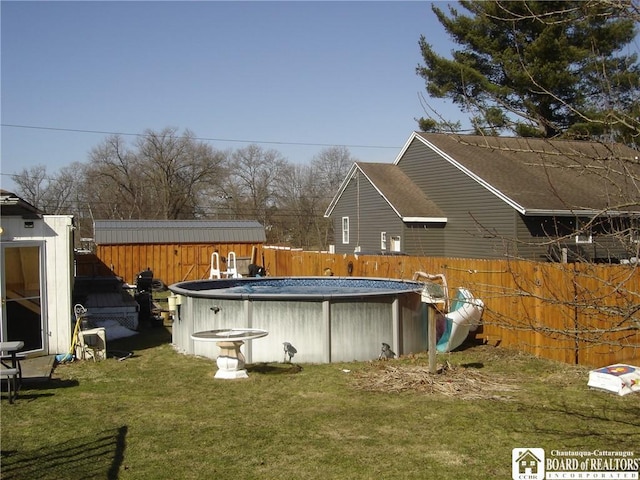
xmin=169 ymin=277 xmax=427 ymax=363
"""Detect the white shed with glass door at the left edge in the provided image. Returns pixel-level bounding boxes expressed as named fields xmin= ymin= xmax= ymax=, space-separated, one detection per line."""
xmin=0 ymin=190 xmax=75 ymax=356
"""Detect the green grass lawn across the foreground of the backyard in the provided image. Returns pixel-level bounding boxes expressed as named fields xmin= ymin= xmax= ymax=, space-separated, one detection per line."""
xmin=1 ymin=327 xmax=640 ymax=480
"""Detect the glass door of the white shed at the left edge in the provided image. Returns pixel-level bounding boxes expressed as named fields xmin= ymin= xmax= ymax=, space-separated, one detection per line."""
xmin=0 ymin=243 xmax=44 ymax=351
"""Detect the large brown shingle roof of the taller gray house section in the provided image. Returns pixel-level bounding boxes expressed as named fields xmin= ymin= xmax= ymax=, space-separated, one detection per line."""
xmin=404 ymin=132 xmax=640 ymax=215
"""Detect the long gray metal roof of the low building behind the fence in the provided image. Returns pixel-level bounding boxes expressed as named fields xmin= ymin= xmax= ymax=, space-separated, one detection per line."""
xmin=93 ymin=220 xmax=266 ymax=245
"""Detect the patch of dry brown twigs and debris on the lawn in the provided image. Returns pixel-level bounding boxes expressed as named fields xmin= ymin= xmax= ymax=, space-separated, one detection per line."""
xmin=353 ymin=361 xmax=518 ymax=400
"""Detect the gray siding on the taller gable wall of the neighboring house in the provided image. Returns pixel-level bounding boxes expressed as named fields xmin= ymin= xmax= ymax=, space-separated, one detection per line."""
xmin=397 ymin=140 xmax=517 ymax=258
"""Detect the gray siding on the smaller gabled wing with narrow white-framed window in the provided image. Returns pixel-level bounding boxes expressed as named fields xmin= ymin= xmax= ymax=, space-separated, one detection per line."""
xmin=331 ymin=172 xmax=403 ymax=253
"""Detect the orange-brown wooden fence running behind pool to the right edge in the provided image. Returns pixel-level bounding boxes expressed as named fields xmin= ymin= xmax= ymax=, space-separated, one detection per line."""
xmin=263 ymin=248 xmax=640 ymax=366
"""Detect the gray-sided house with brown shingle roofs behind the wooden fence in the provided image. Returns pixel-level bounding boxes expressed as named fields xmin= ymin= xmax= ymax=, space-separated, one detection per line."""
xmin=325 ymin=132 xmax=640 ymax=262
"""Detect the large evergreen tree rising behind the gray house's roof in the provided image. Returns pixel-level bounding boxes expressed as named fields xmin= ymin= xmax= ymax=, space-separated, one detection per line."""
xmin=416 ymin=0 xmax=640 ymax=144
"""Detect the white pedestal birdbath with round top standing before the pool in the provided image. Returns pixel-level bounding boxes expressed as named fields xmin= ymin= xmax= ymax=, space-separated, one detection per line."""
xmin=191 ymin=328 xmax=269 ymax=379
